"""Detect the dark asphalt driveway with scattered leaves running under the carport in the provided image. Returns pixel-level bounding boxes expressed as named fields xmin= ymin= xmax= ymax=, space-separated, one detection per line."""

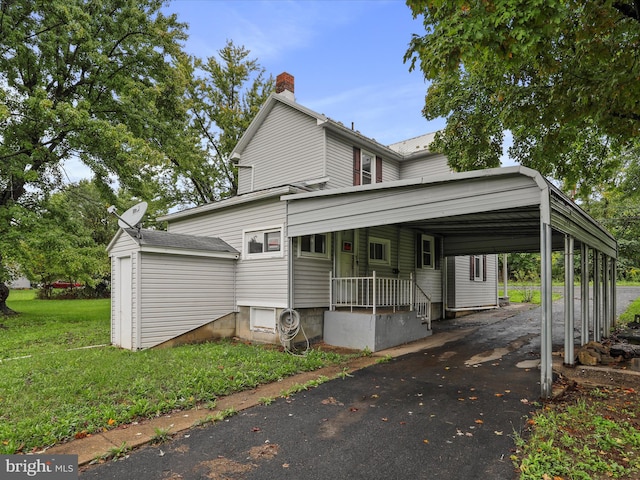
xmin=80 ymin=289 xmax=640 ymax=480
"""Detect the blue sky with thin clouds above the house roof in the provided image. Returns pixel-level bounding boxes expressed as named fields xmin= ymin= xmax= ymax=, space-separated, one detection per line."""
xmin=165 ymin=0 xmax=444 ymax=144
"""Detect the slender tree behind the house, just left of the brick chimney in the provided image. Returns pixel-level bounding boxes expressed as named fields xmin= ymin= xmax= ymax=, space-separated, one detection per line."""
xmin=165 ymin=40 xmax=274 ymax=205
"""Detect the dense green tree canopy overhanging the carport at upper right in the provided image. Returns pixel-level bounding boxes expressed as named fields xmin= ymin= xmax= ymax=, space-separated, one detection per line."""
xmin=405 ymin=0 xmax=640 ymax=196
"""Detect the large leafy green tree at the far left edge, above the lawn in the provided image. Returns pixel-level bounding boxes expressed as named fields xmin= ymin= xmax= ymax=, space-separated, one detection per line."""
xmin=0 ymin=0 xmax=187 ymax=309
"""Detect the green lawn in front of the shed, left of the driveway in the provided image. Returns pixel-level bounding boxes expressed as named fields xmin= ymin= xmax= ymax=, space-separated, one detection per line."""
xmin=0 ymin=291 xmax=358 ymax=454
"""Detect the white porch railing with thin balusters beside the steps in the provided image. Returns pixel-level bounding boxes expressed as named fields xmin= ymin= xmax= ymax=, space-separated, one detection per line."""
xmin=330 ymin=271 xmax=431 ymax=328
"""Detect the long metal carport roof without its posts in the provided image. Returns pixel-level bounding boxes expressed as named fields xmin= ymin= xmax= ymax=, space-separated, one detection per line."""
xmin=282 ymin=166 xmax=617 ymax=258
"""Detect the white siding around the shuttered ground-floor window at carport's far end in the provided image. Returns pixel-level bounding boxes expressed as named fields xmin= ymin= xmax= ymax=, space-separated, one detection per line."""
xmin=447 ymin=255 xmax=498 ymax=308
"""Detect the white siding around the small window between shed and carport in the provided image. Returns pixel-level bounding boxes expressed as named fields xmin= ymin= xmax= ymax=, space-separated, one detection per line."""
xmin=168 ymin=197 xmax=289 ymax=308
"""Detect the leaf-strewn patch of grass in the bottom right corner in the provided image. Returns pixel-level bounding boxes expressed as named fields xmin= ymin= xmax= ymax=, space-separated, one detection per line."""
xmin=512 ymin=388 xmax=640 ymax=480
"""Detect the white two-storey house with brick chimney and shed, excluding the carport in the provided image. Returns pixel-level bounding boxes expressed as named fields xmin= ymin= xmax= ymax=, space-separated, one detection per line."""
xmin=109 ymin=73 xmax=498 ymax=350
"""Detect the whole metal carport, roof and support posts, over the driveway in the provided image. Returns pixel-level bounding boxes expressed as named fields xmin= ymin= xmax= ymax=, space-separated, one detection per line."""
xmin=282 ymin=167 xmax=617 ymax=398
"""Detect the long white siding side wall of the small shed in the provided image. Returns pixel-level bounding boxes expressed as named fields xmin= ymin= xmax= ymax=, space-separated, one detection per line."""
xmin=138 ymin=253 xmax=235 ymax=348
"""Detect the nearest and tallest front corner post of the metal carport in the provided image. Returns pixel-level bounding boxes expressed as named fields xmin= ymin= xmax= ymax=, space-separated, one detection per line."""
xmin=540 ymin=222 xmax=553 ymax=398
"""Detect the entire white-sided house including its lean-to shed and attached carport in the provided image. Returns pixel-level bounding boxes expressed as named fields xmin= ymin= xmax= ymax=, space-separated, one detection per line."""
xmin=108 ymin=73 xmax=617 ymax=398
